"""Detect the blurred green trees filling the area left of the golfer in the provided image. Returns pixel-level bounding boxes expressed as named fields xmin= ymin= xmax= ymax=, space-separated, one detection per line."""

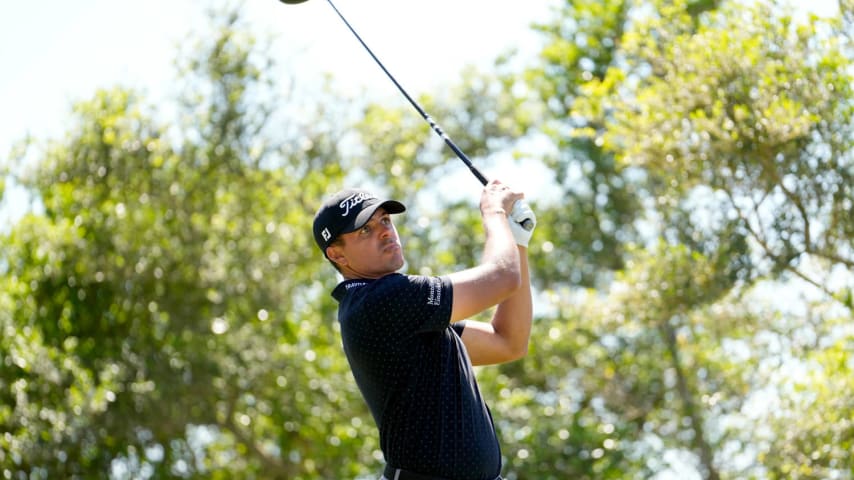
xmin=0 ymin=8 xmax=377 ymax=478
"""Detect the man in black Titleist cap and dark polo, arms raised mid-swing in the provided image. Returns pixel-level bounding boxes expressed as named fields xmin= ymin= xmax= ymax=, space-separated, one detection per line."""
xmin=314 ymin=180 xmax=536 ymax=480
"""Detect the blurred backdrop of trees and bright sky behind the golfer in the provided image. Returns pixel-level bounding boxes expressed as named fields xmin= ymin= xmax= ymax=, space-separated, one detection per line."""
xmin=0 ymin=0 xmax=854 ymax=480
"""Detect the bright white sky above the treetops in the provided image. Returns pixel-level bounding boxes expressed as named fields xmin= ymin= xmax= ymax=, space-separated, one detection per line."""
xmin=0 ymin=0 xmax=836 ymax=228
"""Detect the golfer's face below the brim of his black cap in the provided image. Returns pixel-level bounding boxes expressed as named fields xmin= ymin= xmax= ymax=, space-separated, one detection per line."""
xmin=327 ymin=208 xmax=404 ymax=278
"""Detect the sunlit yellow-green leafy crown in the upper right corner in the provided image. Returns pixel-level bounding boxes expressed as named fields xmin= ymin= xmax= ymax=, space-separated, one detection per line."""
xmin=579 ymin=2 xmax=854 ymax=293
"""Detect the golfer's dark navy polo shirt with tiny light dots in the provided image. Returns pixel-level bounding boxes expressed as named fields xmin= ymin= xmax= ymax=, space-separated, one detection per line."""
xmin=332 ymin=274 xmax=501 ymax=480
